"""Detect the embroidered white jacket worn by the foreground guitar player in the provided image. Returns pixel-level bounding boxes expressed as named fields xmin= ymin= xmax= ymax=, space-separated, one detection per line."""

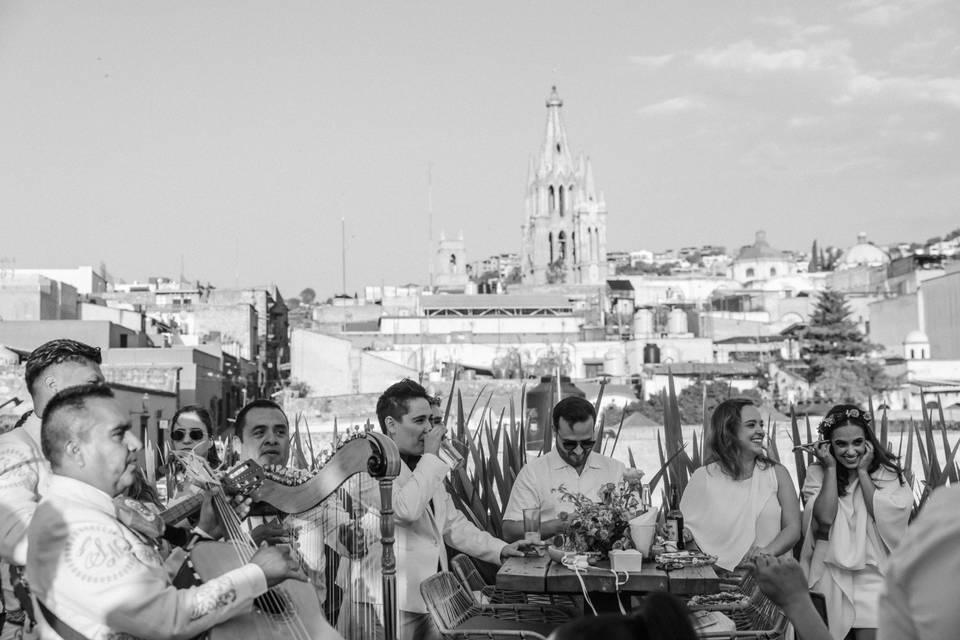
xmin=27 ymin=475 xmax=267 ymax=640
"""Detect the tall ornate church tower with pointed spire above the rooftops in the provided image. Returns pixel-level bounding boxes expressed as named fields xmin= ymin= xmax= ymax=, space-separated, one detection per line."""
xmin=520 ymin=87 xmax=607 ymax=284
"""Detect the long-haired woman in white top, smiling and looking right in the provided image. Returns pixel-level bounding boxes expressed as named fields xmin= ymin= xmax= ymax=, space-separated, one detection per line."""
xmin=680 ymin=398 xmax=800 ymax=570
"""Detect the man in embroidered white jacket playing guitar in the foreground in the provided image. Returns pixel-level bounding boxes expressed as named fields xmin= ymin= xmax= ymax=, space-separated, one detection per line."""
xmin=27 ymin=385 xmax=303 ymax=639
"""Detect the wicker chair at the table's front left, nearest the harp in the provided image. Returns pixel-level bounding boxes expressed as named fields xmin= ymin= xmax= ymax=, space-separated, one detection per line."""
xmin=420 ymin=571 xmax=571 ymax=640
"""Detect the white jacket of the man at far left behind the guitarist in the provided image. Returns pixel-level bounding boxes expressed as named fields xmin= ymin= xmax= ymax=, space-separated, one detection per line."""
xmin=0 ymin=414 xmax=50 ymax=567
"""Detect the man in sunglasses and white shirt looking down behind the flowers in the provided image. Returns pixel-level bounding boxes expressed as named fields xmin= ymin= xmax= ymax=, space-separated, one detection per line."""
xmin=503 ymin=396 xmax=640 ymax=540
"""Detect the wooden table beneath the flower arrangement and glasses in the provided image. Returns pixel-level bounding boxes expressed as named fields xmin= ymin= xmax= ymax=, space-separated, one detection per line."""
xmin=497 ymin=555 xmax=720 ymax=596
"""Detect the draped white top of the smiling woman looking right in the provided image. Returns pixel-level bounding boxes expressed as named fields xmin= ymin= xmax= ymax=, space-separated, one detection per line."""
xmin=680 ymin=462 xmax=781 ymax=571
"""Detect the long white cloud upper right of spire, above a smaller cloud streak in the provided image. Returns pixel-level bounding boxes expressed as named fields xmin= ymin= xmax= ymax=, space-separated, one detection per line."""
xmin=694 ymin=39 xmax=852 ymax=73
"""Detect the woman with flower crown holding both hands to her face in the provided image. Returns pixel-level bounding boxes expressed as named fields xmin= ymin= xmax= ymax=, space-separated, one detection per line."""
xmin=800 ymin=404 xmax=913 ymax=640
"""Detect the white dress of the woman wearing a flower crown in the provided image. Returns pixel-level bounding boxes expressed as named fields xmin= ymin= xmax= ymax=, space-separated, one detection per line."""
xmin=800 ymin=464 xmax=913 ymax=640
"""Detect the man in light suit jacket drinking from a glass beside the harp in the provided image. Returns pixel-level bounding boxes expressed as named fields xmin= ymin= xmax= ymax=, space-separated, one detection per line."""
xmin=338 ymin=380 xmax=529 ymax=640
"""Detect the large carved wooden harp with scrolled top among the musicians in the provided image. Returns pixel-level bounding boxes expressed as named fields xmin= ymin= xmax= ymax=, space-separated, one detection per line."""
xmin=251 ymin=431 xmax=400 ymax=640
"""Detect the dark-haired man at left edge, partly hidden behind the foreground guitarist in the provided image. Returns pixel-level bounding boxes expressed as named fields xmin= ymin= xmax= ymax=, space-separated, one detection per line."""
xmin=0 ymin=339 xmax=103 ymax=638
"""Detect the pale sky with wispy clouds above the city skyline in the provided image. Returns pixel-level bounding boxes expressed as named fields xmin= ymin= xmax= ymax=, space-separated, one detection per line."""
xmin=0 ymin=0 xmax=960 ymax=298
